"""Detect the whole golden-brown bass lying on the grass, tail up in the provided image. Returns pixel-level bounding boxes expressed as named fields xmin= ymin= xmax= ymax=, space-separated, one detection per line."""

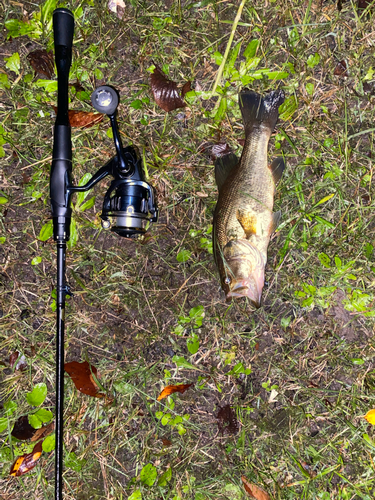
xmin=213 ymin=89 xmax=285 ymax=308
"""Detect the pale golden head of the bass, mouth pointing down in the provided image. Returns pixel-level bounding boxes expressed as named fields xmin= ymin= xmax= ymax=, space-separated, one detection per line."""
xmin=222 ymin=240 xmax=265 ymax=307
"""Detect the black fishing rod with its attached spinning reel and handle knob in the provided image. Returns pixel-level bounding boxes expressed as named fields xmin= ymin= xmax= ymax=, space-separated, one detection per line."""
xmin=50 ymin=8 xmax=158 ymax=500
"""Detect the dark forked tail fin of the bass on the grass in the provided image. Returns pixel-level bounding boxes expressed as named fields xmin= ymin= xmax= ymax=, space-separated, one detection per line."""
xmin=239 ymin=89 xmax=285 ymax=137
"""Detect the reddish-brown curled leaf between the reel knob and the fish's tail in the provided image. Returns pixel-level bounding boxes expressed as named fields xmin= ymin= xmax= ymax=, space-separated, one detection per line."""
xmin=151 ymin=65 xmax=191 ymax=112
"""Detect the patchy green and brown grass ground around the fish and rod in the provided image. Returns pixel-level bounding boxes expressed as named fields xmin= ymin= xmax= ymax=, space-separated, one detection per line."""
xmin=0 ymin=0 xmax=375 ymax=500
